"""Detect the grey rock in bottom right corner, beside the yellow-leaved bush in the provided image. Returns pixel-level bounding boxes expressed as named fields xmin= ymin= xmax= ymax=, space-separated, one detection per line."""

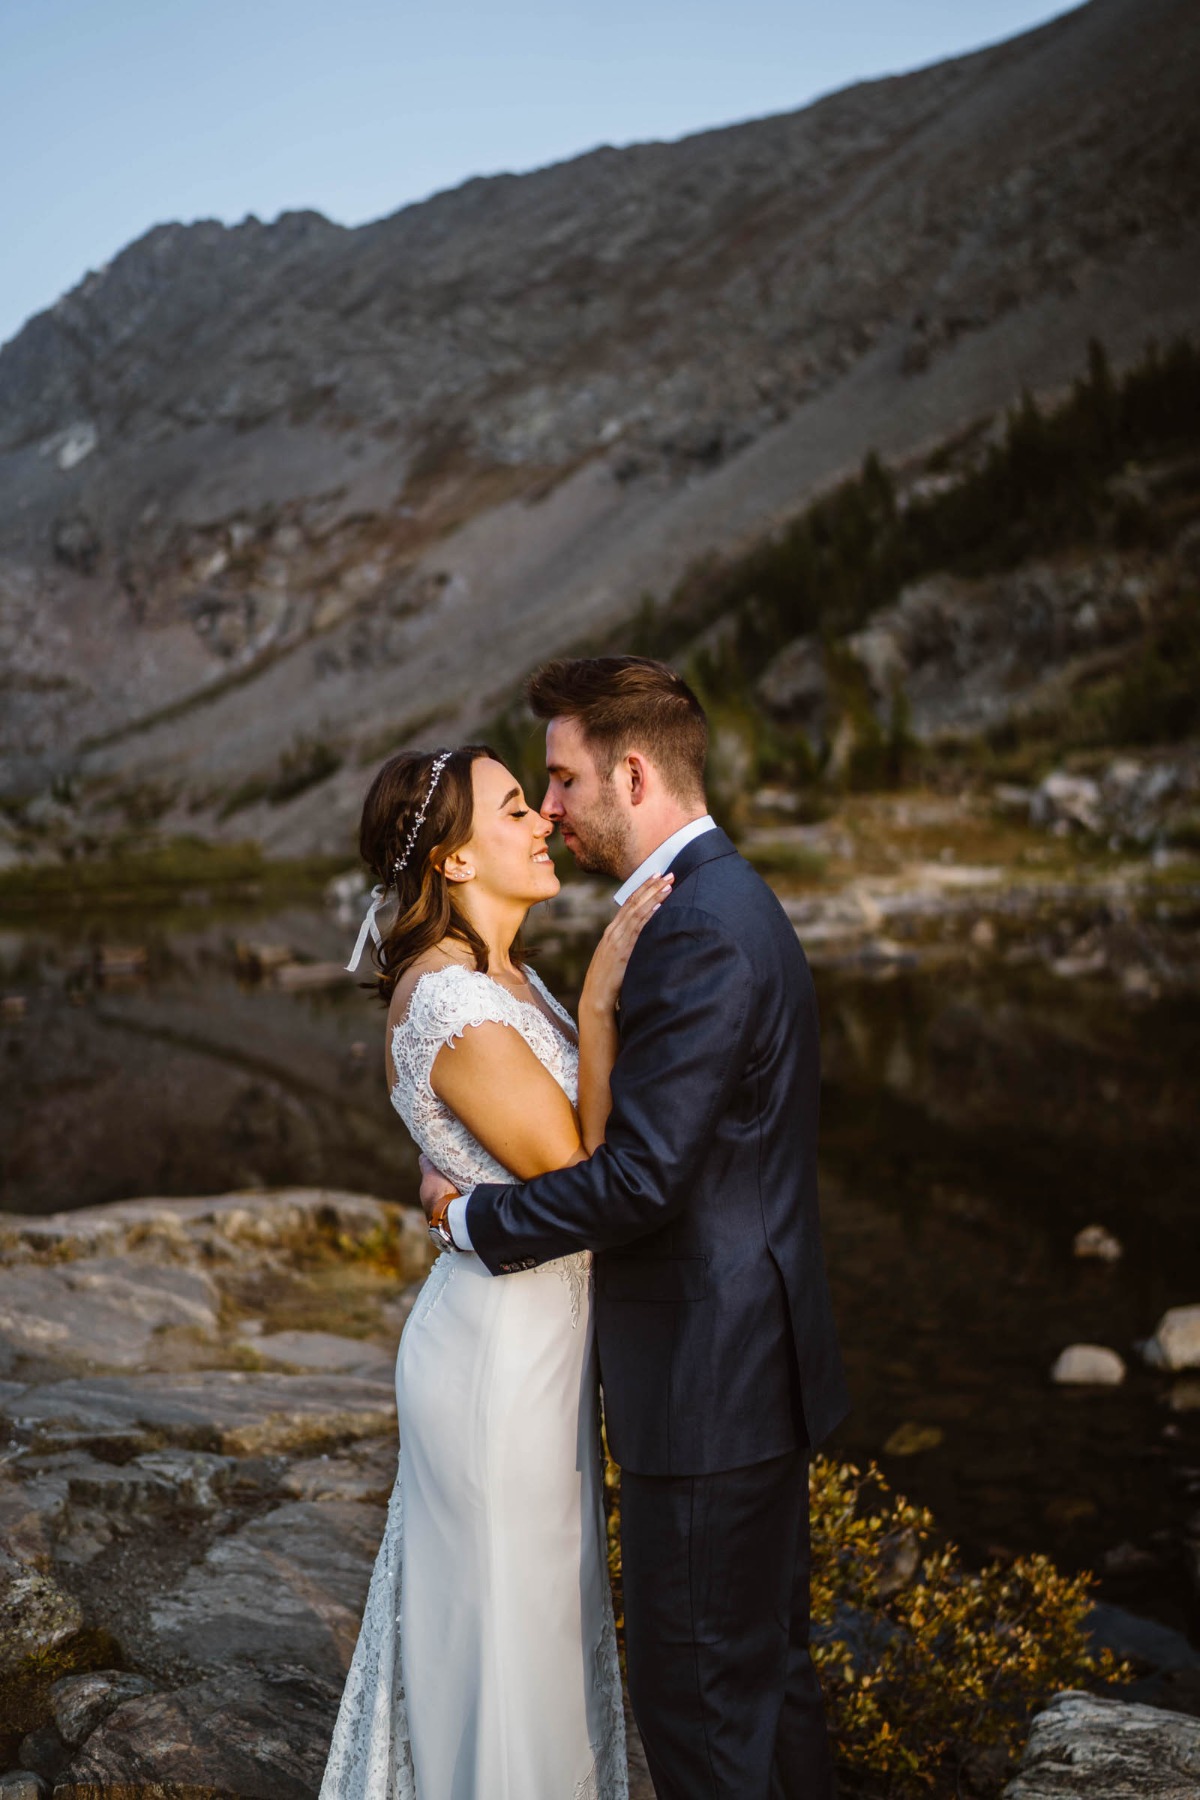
xmin=1004 ymin=1692 xmax=1200 ymax=1800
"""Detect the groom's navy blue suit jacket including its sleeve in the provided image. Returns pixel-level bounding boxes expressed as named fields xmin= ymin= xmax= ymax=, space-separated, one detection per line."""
xmin=466 ymin=830 xmax=847 ymax=1474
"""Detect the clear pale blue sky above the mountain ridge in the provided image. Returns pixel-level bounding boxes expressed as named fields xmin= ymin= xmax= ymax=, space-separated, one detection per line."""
xmin=0 ymin=0 xmax=1063 ymax=342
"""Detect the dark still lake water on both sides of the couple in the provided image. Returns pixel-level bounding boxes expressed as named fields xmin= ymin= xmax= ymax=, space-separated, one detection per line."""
xmin=0 ymin=905 xmax=1200 ymax=1629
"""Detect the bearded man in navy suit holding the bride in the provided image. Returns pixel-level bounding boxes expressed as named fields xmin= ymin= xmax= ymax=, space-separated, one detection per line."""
xmin=421 ymin=657 xmax=846 ymax=1800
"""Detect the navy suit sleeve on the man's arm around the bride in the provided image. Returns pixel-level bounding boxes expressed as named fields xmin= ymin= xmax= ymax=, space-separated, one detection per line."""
xmin=466 ymin=902 xmax=752 ymax=1274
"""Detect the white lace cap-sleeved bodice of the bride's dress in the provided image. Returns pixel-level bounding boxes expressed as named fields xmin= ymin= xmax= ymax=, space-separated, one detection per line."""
xmin=392 ymin=963 xmax=579 ymax=1188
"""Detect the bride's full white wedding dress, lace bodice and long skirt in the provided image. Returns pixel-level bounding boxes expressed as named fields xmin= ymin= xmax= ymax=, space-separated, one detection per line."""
xmin=320 ymin=965 xmax=628 ymax=1800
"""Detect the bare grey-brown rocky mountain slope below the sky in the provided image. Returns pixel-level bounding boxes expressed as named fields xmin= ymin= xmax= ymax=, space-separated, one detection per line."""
xmin=0 ymin=0 xmax=1200 ymax=851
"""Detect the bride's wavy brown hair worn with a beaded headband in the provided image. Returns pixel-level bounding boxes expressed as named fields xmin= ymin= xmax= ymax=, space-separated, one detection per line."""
xmin=358 ymin=743 xmax=524 ymax=1001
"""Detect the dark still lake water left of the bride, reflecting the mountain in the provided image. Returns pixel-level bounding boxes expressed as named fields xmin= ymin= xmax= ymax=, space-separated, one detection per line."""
xmin=0 ymin=916 xmax=416 ymax=1211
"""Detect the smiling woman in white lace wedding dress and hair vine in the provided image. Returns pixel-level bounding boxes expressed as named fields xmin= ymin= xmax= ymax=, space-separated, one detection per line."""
xmin=320 ymin=745 xmax=671 ymax=1800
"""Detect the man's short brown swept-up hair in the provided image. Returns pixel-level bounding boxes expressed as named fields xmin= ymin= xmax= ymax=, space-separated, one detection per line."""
xmin=525 ymin=657 xmax=709 ymax=805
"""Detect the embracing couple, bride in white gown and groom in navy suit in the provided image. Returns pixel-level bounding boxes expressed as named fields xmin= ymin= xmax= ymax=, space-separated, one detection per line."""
xmin=322 ymin=657 xmax=846 ymax=1800
